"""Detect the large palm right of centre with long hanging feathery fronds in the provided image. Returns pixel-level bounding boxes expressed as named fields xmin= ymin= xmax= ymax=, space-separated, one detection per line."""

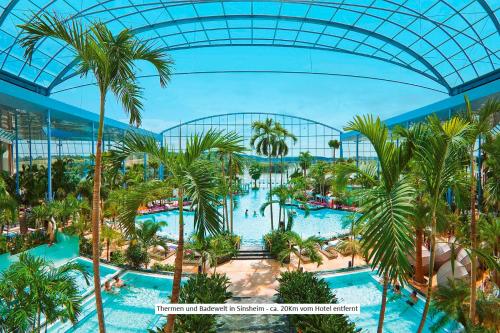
xmin=346 ymin=116 xmax=414 ymax=333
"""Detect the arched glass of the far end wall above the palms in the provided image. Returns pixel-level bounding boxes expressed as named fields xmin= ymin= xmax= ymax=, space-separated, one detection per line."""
xmin=160 ymin=112 xmax=342 ymax=160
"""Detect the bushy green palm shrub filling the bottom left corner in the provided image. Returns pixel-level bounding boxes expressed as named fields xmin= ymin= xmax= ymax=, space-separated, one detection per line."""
xmin=0 ymin=253 xmax=88 ymax=332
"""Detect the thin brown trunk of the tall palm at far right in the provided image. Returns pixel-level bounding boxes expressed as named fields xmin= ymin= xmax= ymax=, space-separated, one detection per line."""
xmin=469 ymin=146 xmax=477 ymax=324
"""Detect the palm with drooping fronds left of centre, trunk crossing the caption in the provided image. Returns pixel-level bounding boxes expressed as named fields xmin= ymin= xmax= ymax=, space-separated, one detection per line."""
xmin=113 ymin=130 xmax=245 ymax=333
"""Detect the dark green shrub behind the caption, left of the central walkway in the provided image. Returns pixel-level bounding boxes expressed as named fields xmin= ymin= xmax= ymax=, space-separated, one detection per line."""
xmin=174 ymin=274 xmax=232 ymax=333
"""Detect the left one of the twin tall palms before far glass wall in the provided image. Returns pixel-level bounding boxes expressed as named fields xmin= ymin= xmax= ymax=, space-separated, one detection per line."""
xmin=250 ymin=118 xmax=279 ymax=230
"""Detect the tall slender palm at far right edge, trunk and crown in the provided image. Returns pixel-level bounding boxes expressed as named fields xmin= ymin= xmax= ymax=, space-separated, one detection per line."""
xmin=463 ymin=96 xmax=500 ymax=323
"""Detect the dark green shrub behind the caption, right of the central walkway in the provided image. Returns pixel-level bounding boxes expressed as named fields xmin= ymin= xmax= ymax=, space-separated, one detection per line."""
xmin=278 ymin=271 xmax=355 ymax=333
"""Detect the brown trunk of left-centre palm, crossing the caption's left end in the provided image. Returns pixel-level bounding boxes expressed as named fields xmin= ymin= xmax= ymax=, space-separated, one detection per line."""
xmin=163 ymin=188 xmax=184 ymax=333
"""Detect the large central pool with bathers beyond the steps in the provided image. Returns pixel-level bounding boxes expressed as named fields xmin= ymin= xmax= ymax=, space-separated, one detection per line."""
xmin=137 ymin=190 xmax=352 ymax=245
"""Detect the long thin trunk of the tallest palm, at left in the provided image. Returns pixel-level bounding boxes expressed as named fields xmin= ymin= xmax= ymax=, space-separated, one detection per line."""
xmin=92 ymin=91 xmax=106 ymax=333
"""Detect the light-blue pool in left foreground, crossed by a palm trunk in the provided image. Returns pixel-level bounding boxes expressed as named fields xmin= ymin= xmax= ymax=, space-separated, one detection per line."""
xmin=49 ymin=272 xmax=172 ymax=333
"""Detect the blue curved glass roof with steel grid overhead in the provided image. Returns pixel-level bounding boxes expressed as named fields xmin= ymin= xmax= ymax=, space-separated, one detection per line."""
xmin=0 ymin=0 xmax=500 ymax=94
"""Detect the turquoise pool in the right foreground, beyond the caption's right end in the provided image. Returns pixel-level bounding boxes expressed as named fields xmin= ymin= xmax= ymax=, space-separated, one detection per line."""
xmin=323 ymin=271 xmax=452 ymax=333
